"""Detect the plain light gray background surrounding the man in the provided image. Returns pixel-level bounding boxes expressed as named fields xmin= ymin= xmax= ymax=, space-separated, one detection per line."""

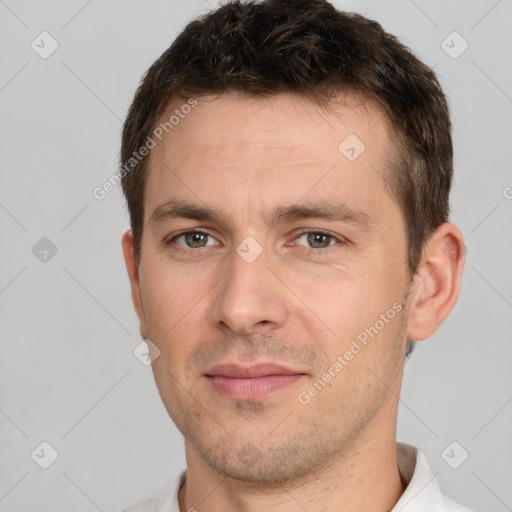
xmin=0 ymin=0 xmax=512 ymax=512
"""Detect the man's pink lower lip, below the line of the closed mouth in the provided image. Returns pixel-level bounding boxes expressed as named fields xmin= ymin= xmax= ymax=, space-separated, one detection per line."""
xmin=208 ymin=375 xmax=304 ymax=400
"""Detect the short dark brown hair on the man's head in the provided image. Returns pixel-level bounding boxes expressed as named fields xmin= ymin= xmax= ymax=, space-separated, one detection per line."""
xmin=121 ymin=0 xmax=453 ymax=354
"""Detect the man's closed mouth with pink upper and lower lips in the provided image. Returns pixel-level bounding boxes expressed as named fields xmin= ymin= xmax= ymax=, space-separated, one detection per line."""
xmin=205 ymin=363 xmax=306 ymax=400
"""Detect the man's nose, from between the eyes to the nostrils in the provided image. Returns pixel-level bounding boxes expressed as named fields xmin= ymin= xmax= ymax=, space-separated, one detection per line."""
xmin=213 ymin=243 xmax=288 ymax=335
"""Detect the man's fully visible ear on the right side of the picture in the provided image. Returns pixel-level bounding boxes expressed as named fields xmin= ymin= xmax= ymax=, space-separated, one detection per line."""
xmin=407 ymin=222 xmax=465 ymax=341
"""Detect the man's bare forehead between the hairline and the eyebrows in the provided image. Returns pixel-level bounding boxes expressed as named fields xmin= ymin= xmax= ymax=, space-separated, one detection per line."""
xmin=145 ymin=93 xmax=392 ymax=224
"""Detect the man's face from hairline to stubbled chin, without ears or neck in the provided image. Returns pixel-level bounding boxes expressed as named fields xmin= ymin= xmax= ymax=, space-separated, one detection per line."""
xmin=127 ymin=94 xmax=409 ymax=483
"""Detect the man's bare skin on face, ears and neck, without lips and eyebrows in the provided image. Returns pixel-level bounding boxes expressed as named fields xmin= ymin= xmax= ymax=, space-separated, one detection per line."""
xmin=122 ymin=93 xmax=464 ymax=512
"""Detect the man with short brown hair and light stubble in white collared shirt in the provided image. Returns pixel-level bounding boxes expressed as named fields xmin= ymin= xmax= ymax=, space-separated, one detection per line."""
xmin=120 ymin=0 xmax=468 ymax=512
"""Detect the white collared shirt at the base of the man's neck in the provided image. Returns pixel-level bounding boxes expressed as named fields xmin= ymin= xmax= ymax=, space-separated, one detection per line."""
xmin=123 ymin=442 xmax=472 ymax=512
